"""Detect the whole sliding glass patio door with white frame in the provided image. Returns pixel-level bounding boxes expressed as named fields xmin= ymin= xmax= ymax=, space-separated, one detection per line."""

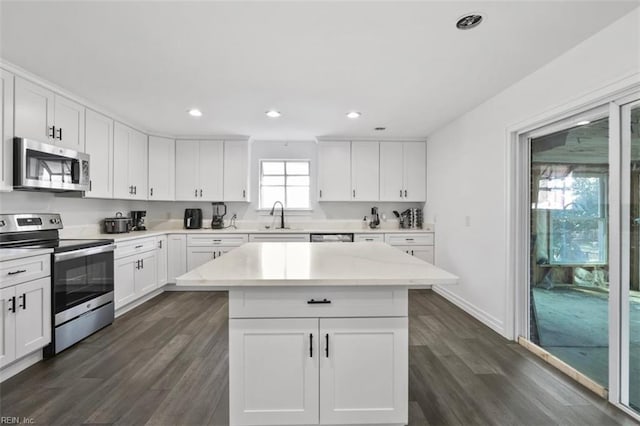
xmin=517 ymin=95 xmax=640 ymax=418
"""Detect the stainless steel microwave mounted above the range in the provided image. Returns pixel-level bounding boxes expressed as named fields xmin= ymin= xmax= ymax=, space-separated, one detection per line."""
xmin=13 ymin=138 xmax=89 ymax=192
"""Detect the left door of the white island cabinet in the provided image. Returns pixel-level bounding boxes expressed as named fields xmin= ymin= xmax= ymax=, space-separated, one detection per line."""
xmin=229 ymin=318 xmax=320 ymax=425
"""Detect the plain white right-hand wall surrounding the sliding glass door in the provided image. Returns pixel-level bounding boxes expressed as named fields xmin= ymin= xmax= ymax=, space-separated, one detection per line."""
xmin=426 ymin=9 xmax=640 ymax=337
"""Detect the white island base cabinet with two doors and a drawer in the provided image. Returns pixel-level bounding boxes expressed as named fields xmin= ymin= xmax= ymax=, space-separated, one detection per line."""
xmin=229 ymin=288 xmax=409 ymax=426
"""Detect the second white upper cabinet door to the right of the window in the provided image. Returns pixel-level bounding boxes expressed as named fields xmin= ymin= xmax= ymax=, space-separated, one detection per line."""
xmin=351 ymin=142 xmax=380 ymax=201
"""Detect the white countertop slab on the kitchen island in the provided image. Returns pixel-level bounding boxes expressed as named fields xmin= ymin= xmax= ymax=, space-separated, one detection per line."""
xmin=177 ymin=242 xmax=458 ymax=288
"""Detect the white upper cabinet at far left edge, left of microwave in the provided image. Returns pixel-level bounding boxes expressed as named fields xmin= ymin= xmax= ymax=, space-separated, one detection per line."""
xmin=0 ymin=69 xmax=13 ymax=191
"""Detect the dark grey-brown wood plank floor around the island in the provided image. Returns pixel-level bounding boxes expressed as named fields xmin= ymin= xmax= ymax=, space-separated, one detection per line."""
xmin=0 ymin=290 xmax=637 ymax=426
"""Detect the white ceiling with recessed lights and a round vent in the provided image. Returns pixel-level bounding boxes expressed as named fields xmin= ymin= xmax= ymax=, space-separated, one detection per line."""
xmin=0 ymin=1 xmax=639 ymax=140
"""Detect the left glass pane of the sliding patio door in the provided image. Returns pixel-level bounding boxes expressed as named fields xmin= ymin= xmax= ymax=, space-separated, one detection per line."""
xmin=529 ymin=110 xmax=610 ymax=387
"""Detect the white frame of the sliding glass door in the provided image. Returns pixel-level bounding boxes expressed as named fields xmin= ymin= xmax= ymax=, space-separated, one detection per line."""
xmin=505 ymin=83 xmax=640 ymax=420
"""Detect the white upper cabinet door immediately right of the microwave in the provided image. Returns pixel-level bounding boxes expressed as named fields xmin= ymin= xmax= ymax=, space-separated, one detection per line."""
xmin=84 ymin=109 xmax=113 ymax=198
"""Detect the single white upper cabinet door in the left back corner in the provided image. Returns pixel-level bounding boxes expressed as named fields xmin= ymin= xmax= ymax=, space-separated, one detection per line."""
xmin=149 ymin=136 xmax=176 ymax=201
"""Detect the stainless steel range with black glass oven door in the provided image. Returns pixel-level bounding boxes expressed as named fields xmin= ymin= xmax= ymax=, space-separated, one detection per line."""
xmin=0 ymin=213 xmax=114 ymax=357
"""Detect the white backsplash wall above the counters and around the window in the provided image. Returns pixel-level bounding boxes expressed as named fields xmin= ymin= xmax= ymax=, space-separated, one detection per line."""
xmin=0 ymin=141 xmax=423 ymax=227
